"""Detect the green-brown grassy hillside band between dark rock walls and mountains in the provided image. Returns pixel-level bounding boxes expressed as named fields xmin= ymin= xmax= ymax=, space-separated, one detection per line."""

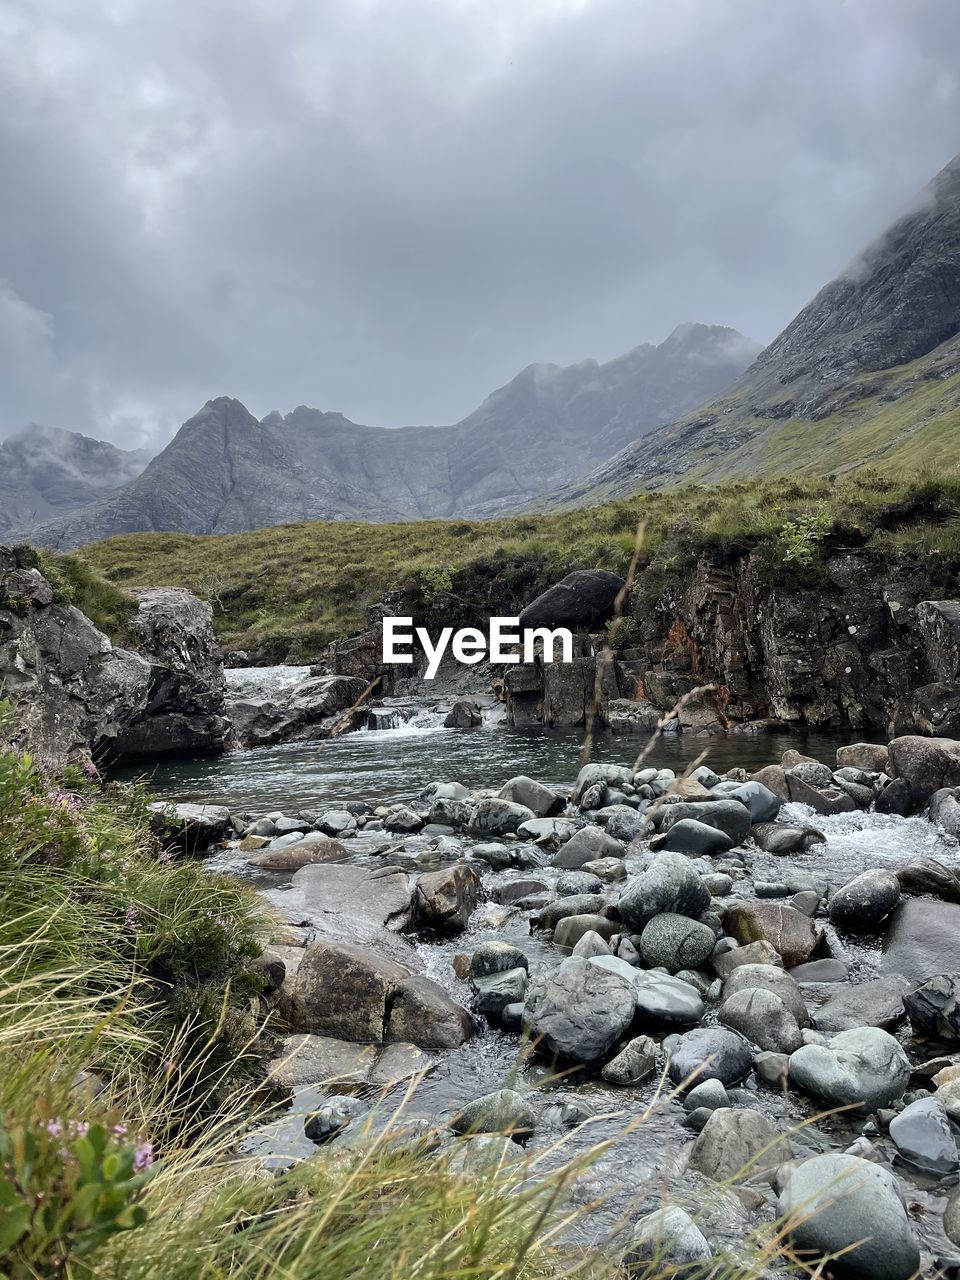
xmin=77 ymin=471 xmax=960 ymax=659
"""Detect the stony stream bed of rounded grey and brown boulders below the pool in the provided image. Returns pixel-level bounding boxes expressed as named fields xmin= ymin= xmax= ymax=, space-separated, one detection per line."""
xmin=148 ymin=736 xmax=960 ymax=1280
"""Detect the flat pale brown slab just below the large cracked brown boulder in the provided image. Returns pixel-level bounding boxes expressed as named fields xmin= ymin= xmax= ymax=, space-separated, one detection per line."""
xmin=268 ymin=1033 xmax=436 ymax=1092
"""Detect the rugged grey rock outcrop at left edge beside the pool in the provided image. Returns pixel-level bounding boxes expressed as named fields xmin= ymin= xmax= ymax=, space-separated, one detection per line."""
xmin=0 ymin=547 xmax=229 ymax=764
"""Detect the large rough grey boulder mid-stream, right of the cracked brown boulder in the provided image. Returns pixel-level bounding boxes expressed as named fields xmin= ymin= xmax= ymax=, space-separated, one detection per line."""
xmin=524 ymin=956 xmax=636 ymax=1062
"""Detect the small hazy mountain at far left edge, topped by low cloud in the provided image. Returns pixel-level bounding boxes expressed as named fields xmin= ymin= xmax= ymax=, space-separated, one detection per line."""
xmin=0 ymin=425 xmax=150 ymax=536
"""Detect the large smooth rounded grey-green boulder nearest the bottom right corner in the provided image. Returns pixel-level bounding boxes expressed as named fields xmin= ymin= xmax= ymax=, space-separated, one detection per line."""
xmin=777 ymin=1155 xmax=920 ymax=1280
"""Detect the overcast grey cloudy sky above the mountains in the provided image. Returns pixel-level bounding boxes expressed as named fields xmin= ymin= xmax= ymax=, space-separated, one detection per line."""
xmin=0 ymin=0 xmax=960 ymax=444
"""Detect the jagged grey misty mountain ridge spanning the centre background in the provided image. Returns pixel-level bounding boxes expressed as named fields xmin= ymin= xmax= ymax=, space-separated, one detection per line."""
xmin=11 ymin=325 xmax=759 ymax=548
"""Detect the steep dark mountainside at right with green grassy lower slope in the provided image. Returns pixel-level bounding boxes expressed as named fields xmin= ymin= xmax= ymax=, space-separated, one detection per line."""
xmin=539 ymin=156 xmax=960 ymax=508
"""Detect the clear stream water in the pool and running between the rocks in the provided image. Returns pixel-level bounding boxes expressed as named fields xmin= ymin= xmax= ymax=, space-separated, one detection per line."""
xmin=108 ymin=704 xmax=960 ymax=1257
